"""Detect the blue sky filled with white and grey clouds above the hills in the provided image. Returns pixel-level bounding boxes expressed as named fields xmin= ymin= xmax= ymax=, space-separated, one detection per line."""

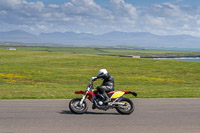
xmin=0 ymin=0 xmax=200 ymax=37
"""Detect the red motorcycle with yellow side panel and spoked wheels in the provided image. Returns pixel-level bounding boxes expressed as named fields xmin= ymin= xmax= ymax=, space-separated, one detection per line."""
xmin=69 ymin=80 xmax=137 ymax=115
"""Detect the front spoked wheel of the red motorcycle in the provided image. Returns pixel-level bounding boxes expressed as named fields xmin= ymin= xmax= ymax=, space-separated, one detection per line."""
xmin=69 ymin=98 xmax=88 ymax=114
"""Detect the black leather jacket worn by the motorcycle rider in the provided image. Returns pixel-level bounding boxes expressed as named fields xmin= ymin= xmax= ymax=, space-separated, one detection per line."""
xmin=97 ymin=73 xmax=114 ymax=89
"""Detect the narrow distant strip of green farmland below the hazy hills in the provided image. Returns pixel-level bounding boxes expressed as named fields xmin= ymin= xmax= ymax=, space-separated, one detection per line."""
xmin=0 ymin=46 xmax=200 ymax=57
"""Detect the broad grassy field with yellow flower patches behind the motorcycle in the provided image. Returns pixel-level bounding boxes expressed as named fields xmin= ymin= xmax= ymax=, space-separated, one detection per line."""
xmin=0 ymin=47 xmax=200 ymax=99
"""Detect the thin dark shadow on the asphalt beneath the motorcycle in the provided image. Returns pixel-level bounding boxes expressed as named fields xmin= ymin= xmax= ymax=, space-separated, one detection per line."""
xmin=59 ymin=110 xmax=120 ymax=115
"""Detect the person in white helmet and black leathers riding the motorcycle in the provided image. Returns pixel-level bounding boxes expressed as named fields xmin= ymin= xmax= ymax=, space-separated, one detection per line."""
xmin=94 ymin=69 xmax=114 ymax=103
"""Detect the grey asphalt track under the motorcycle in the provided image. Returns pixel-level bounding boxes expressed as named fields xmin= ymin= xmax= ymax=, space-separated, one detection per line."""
xmin=0 ymin=98 xmax=200 ymax=133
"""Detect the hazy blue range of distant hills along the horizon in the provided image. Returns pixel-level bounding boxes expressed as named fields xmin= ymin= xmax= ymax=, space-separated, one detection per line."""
xmin=0 ymin=30 xmax=200 ymax=48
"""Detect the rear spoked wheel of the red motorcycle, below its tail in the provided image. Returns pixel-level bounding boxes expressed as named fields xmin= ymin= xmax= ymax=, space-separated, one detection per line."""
xmin=116 ymin=98 xmax=135 ymax=115
